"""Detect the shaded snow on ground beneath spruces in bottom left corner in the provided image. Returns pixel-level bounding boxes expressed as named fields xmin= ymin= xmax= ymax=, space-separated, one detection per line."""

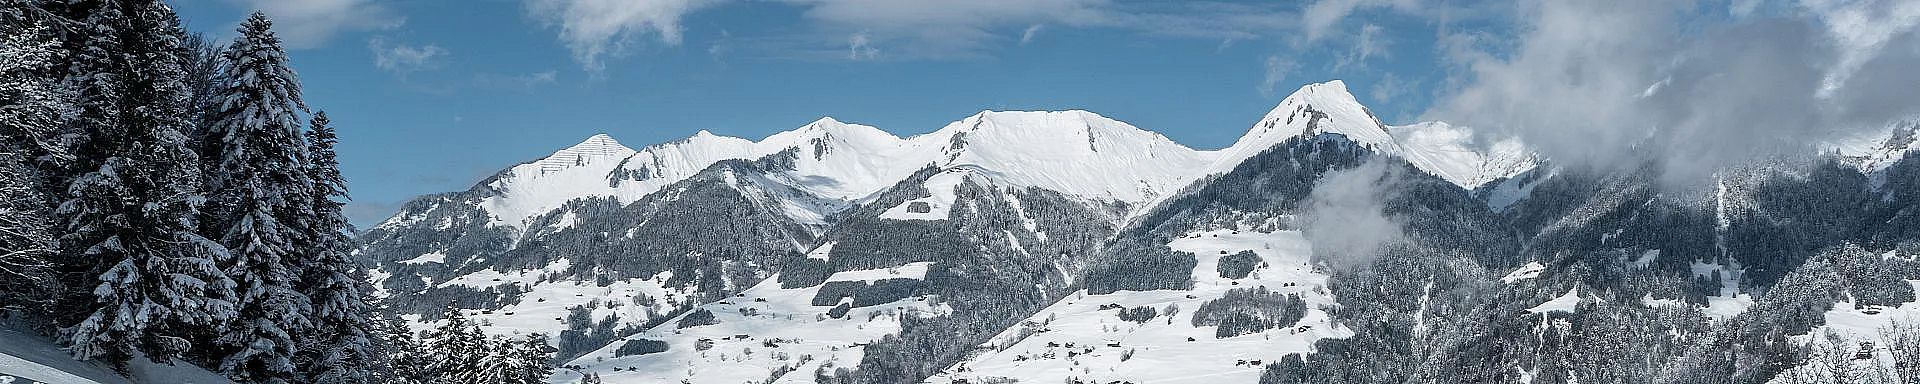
xmin=0 ymin=324 xmax=227 ymax=384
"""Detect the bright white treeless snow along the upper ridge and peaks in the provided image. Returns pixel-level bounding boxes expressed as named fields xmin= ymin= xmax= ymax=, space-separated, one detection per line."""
xmin=380 ymin=81 xmax=1534 ymax=238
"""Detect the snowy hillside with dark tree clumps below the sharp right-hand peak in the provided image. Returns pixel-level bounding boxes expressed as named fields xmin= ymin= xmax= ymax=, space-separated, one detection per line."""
xmin=927 ymin=230 xmax=1352 ymax=384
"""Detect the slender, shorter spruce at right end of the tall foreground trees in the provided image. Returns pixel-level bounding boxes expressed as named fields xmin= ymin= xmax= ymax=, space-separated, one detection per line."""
xmin=300 ymin=111 xmax=376 ymax=384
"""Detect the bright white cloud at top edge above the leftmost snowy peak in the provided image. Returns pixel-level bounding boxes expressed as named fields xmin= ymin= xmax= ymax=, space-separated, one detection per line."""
xmin=526 ymin=0 xmax=718 ymax=71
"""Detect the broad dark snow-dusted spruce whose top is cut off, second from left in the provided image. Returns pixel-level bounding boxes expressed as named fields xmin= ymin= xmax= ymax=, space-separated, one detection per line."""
xmin=56 ymin=0 xmax=234 ymax=363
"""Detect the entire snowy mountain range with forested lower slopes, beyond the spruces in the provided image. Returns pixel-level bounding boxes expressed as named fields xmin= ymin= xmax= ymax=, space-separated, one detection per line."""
xmin=359 ymin=81 xmax=1920 ymax=382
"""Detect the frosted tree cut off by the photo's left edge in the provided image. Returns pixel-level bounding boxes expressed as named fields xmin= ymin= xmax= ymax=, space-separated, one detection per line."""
xmin=0 ymin=0 xmax=71 ymax=309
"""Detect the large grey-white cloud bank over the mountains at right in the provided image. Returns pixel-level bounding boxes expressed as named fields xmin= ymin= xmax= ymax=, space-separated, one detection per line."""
xmin=1427 ymin=0 xmax=1920 ymax=182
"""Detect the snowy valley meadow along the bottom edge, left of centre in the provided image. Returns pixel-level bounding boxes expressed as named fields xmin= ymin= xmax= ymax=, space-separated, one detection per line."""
xmin=547 ymin=272 xmax=950 ymax=384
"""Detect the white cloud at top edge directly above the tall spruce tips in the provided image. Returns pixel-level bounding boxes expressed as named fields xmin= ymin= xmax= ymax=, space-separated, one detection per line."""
xmin=234 ymin=0 xmax=407 ymax=48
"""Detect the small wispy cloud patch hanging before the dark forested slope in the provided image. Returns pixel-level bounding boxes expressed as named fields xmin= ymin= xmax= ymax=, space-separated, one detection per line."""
xmin=1300 ymin=159 xmax=1405 ymax=267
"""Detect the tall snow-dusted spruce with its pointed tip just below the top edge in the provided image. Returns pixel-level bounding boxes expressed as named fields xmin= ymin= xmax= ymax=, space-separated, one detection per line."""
xmin=204 ymin=12 xmax=313 ymax=382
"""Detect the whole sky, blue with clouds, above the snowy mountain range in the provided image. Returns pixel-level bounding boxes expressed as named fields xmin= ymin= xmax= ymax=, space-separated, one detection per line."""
xmin=173 ymin=0 xmax=1920 ymax=225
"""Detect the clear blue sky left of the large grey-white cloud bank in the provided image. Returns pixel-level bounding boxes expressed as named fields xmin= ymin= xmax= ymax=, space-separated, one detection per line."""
xmin=175 ymin=0 xmax=1466 ymax=225
